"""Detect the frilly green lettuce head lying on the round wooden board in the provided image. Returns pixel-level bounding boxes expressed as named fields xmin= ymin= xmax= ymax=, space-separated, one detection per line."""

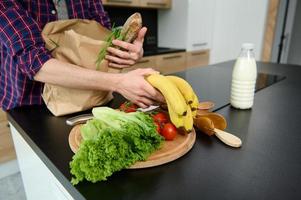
xmin=70 ymin=107 xmax=163 ymax=185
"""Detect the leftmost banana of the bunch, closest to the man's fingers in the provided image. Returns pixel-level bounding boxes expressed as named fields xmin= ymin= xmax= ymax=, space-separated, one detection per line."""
xmin=146 ymin=74 xmax=187 ymax=116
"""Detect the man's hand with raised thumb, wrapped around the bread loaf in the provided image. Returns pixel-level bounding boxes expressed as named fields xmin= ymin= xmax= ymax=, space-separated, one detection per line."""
xmin=106 ymin=27 xmax=147 ymax=68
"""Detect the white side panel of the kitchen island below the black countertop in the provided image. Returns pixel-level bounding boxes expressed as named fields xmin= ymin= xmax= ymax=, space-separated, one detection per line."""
xmin=10 ymin=124 xmax=74 ymax=200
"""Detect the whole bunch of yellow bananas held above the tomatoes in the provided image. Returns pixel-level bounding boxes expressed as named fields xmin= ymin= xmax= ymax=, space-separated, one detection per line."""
xmin=146 ymin=74 xmax=199 ymax=133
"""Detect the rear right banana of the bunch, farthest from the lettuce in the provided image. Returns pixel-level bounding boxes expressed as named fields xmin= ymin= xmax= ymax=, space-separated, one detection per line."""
xmin=166 ymin=76 xmax=195 ymax=104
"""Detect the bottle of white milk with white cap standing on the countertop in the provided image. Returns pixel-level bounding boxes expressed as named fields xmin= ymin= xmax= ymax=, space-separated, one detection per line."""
xmin=230 ymin=43 xmax=257 ymax=109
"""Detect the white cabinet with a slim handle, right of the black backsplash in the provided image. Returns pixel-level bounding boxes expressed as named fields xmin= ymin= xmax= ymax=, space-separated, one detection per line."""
xmin=158 ymin=0 xmax=215 ymax=51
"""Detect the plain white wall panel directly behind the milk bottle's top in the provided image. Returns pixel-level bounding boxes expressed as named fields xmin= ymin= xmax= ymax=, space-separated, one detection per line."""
xmin=211 ymin=0 xmax=268 ymax=63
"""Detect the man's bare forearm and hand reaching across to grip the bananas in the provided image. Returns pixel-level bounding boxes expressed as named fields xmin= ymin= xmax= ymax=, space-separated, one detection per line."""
xmin=34 ymin=58 xmax=165 ymax=108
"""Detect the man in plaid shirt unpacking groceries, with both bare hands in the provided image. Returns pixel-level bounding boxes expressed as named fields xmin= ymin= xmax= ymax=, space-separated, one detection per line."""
xmin=0 ymin=0 xmax=162 ymax=110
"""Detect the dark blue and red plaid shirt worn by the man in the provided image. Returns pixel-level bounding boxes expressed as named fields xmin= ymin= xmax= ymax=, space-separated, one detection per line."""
xmin=0 ymin=0 xmax=110 ymax=110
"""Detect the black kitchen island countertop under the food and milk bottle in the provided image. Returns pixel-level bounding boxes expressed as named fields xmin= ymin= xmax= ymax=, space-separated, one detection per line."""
xmin=8 ymin=61 xmax=301 ymax=200
